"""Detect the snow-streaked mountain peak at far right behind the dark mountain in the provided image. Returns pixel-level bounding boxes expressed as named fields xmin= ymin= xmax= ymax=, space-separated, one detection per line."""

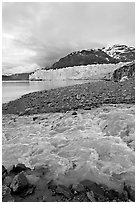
xmin=102 ymin=45 xmax=135 ymax=62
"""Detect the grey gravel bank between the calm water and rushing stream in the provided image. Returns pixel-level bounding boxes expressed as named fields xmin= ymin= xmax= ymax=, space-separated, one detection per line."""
xmin=2 ymin=79 xmax=135 ymax=115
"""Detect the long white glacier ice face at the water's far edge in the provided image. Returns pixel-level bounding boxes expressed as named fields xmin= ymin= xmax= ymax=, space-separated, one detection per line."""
xmin=29 ymin=62 xmax=126 ymax=81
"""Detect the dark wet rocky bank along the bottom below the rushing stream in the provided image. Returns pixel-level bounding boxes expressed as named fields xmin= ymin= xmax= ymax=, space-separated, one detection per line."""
xmin=2 ymin=164 xmax=134 ymax=202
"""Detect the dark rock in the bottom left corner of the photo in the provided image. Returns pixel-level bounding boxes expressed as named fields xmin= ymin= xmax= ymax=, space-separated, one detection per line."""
xmin=2 ymin=185 xmax=15 ymax=202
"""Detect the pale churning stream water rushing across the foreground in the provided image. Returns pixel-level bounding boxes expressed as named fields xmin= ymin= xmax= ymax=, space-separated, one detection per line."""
xmin=3 ymin=105 xmax=135 ymax=190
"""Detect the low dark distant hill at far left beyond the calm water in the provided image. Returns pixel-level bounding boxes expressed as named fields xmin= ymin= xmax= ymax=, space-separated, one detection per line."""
xmin=2 ymin=72 xmax=32 ymax=81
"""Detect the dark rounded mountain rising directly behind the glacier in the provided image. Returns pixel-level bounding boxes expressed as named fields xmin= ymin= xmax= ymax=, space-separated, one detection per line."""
xmin=51 ymin=49 xmax=118 ymax=69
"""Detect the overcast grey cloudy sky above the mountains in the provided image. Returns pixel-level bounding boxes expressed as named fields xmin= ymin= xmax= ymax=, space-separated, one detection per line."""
xmin=2 ymin=2 xmax=135 ymax=73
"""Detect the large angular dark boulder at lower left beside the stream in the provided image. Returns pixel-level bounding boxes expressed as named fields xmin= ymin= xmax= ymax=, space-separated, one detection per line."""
xmin=10 ymin=172 xmax=28 ymax=193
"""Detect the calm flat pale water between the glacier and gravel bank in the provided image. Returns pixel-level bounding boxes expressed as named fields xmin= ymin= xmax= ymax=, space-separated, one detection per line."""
xmin=2 ymin=80 xmax=88 ymax=103
